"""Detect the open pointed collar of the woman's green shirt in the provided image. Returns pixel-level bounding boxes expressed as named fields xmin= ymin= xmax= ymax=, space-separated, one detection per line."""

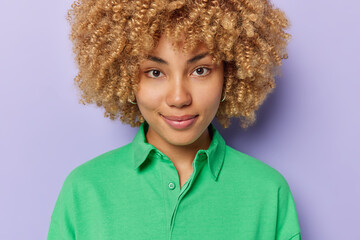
xmin=132 ymin=122 xmax=225 ymax=180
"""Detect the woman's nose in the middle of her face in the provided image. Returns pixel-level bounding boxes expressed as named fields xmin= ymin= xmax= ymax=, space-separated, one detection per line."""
xmin=166 ymin=77 xmax=192 ymax=108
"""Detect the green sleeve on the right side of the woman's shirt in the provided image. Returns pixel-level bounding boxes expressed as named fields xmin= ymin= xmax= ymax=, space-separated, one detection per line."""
xmin=276 ymin=179 xmax=301 ymax=240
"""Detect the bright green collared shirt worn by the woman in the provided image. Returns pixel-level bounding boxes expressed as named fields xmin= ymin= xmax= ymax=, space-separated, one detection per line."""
xmin=47 ymin=123 xmax=301 ymax=240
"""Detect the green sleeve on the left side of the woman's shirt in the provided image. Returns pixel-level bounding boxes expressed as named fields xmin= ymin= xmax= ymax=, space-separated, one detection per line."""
xmin=47 ymin=175 xmax=75 ymax=240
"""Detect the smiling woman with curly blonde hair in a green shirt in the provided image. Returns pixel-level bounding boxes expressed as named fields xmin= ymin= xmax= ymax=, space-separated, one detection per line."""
xmin=48 ymin=0 xmax=301 ymax=240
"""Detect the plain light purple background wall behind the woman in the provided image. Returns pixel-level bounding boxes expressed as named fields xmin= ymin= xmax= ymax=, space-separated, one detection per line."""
xmin=0 ymin=0 xmax=360 ymax=240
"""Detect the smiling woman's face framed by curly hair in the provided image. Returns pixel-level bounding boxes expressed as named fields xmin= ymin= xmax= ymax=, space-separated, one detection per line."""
xmin=136 ymin=33 xmax=224 ymax=146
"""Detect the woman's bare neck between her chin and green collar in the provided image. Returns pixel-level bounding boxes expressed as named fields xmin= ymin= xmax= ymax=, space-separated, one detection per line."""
xmin=146 ymin=127 xmax=211 ymax=169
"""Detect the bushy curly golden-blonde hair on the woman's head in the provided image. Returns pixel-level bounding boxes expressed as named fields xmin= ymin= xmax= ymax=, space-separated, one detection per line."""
xmin=66 ymin=0 xmax=291 ymax=128
